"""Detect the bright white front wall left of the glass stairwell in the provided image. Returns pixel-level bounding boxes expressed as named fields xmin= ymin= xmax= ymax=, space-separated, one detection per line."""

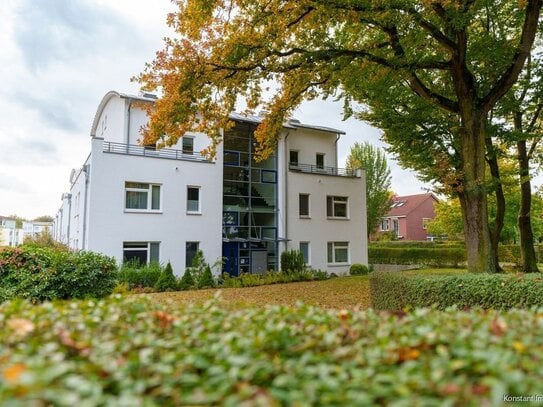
xmin=86 ymin=138 xmax=222 ymax=275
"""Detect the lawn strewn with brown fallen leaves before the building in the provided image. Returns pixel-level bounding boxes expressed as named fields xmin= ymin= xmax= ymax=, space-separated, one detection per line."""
xmin=146 ymin=276 xmax=371 ymax=308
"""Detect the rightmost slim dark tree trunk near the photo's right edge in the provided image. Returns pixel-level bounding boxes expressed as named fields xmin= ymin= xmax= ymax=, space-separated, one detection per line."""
xmin=517 ymin=140 xmax=539 ymax=273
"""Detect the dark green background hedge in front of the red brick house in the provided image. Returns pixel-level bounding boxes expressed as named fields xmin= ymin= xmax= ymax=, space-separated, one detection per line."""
xmin=368 ymin=246 xmax=466 ymax=267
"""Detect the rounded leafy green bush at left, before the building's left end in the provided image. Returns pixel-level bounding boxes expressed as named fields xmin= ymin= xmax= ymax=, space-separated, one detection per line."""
xmin=0 ymin=246 xmax=117 ymax=302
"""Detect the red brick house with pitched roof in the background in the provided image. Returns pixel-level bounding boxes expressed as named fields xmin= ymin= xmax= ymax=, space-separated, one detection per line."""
xmin=377 ymin=193 xmax=438 ymax=240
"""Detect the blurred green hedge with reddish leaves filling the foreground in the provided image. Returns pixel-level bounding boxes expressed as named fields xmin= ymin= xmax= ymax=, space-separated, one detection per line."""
xmin=0 ymin=298 xmax=543 ymax=407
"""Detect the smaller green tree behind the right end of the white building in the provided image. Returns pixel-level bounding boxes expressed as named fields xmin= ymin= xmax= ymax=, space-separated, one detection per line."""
xmin=347 ymin=142 xmax=392 ymax=238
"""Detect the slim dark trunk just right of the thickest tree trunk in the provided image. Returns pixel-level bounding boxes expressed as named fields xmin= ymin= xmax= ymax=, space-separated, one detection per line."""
xmin=486 ymin=137 xmax=505 ymax=272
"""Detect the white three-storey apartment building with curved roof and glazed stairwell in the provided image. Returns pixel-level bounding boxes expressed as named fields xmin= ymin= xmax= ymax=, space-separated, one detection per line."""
xmin=55 ymin=91 xmax=367 ymax=275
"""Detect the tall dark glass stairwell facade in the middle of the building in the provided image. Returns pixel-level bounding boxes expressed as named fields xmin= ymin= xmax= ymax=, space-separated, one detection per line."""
xmin=222 ymin=122 xmax=278 ymax=276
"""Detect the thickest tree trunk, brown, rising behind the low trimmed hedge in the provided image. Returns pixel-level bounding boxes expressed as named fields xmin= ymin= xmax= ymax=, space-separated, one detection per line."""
xmin=458 ymin=115 xmax=497 ymax=273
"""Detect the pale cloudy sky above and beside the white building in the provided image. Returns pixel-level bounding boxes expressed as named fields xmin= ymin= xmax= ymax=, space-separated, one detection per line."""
xmin=0 ymin=0 xmax=425 ymax=219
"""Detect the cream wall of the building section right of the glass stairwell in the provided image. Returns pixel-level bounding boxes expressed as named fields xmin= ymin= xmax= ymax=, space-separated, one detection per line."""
xmin=278 ymin=129 xmax=368 ymax=274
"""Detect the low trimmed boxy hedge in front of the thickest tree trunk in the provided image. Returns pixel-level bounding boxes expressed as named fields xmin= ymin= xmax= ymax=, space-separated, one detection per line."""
xmin=370 ymin=272 xmax=543 ymax=310
